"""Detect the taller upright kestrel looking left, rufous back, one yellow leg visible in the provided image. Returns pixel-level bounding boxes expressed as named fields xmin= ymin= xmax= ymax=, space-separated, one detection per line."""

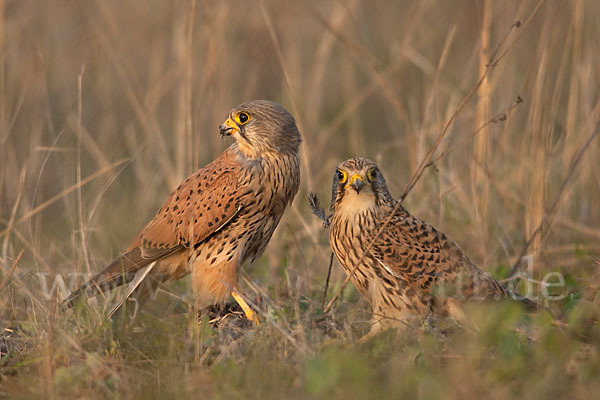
xmin=65 ymin=100 xmax=302 ymax=322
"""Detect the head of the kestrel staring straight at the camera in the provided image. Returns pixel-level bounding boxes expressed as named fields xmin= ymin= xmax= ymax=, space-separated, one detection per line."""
xmin=331 ymin=157 xmax=394 ymax=212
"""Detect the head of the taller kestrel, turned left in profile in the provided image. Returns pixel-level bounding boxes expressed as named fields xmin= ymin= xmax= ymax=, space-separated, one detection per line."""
xmin=219 ymin=100 xmax=302 ymax=158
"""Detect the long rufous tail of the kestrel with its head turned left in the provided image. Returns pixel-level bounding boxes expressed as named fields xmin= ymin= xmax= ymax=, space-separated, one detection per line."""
xmin=64 ymin=247 xmax=150 ymax=308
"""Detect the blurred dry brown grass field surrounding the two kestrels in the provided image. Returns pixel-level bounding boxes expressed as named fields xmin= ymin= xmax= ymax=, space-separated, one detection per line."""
xmin=0 ymin=0 xmax=600 ymax=399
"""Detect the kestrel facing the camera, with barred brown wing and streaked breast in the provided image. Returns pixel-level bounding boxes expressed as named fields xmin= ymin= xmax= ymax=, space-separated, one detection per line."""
xmin=329 ymin=158 xmax=535 ymax=335
